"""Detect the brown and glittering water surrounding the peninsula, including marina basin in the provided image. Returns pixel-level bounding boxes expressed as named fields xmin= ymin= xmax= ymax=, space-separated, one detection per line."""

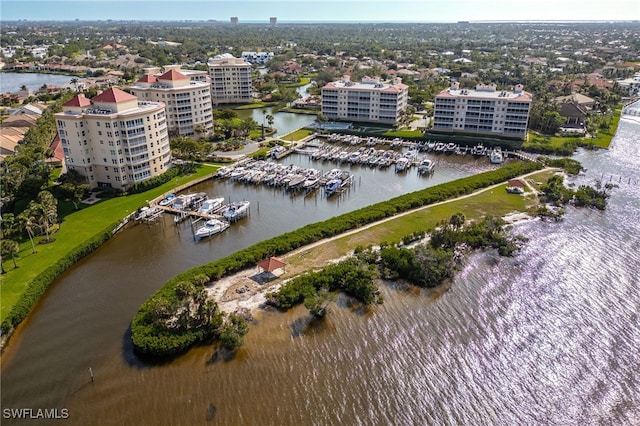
xmin=2 ymin=120 xmax=640 ymax=425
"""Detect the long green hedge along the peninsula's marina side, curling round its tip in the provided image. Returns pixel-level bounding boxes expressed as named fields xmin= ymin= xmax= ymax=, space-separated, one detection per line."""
xmin=131 ymin=162 xmax=542 ymax=356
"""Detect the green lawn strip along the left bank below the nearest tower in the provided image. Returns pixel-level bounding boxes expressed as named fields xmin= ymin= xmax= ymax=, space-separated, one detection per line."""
xmin=0 ymin=165 xmax=218 ymax=322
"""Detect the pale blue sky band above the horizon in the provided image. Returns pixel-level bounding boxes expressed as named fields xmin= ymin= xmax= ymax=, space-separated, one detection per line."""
xmin=0 ymin=0 xmax=640 ymax=23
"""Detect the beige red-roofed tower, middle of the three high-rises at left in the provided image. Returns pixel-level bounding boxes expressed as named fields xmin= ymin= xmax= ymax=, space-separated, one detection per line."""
xmin=130 ymin=66 xmax=213 ymax=137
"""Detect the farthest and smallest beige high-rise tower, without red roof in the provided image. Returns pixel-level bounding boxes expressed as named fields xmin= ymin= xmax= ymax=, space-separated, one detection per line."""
xmin=207 ymin=54 xmax=253 ymax=104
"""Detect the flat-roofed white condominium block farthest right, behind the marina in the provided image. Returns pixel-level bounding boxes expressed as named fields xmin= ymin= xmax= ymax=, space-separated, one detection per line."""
xmin=433 ymin=82 xmax=533 ymax=140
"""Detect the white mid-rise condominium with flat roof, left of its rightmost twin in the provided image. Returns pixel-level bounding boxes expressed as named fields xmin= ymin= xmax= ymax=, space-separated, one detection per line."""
xmin=322 ymin=75 xmax=409 ymax=124
